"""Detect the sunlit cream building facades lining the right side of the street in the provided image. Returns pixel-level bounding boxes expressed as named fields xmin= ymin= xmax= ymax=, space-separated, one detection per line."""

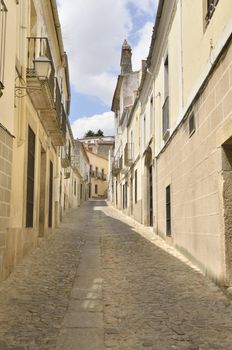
xmin=112 ymin=0 xmax=232 ymax=285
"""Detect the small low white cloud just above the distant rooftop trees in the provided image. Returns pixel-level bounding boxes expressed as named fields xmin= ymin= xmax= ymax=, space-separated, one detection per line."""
xmin=71 ymin=112 xmax=114 ymax=138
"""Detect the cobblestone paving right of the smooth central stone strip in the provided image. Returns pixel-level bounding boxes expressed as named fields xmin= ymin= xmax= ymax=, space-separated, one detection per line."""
xmin=102 ymin=208 xmax=232 ymax=350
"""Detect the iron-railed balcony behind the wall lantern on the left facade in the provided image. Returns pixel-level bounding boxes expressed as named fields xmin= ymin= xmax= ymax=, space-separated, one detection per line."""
xmin=27 ymin=37 xmax=67 ymax=146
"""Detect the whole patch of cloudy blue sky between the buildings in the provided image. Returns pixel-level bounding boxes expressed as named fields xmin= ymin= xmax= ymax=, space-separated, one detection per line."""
xmin=57 ymin=0 xmax=158 ymax=138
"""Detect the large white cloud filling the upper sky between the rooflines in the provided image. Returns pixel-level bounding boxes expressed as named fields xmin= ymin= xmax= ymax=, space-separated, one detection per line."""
xmin=58 ymin=0 xmax=157 ymax=105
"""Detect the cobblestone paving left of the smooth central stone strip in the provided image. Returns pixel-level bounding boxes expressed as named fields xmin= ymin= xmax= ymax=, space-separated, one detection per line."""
xmin=0 ymin=211 xmax=83 ymax=350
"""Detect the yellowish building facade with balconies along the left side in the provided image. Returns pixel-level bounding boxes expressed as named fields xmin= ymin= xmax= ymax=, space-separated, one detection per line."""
xmin=0 ymin=0 xmax=88 ymax=279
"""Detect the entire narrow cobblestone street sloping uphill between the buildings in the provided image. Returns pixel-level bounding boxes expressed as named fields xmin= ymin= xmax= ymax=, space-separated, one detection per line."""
xmin=0 ymin=201 xmax=232 ymax=350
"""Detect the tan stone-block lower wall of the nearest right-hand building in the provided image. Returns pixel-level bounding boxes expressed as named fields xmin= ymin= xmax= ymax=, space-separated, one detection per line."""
xmin=155 ymin=39 xmax=232 ymax=283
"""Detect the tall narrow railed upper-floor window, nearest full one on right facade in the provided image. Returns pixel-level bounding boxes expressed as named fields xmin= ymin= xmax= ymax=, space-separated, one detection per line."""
xmin=163 ymin=55 xmax=169 ymax=139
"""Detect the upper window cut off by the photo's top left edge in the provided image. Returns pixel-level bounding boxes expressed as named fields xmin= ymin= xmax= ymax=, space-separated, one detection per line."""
xmin=0 ymin=0 xmax=7 ymax=97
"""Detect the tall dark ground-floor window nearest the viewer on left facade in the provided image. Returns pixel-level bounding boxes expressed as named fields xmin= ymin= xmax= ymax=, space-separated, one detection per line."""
xmin=26 ymin=127 xmax=35 ymax=227
